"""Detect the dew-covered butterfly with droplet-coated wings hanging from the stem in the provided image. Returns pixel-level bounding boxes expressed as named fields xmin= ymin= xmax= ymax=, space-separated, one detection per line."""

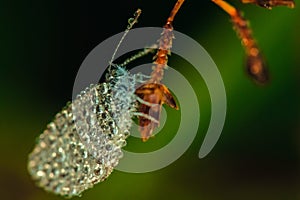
xmin=28 ymin=10 xmax=147 ymax=197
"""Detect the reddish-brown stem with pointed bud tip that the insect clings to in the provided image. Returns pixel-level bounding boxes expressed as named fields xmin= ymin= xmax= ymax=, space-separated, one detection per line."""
xmin=135 ymin=0 xmax=184 ymax=141
